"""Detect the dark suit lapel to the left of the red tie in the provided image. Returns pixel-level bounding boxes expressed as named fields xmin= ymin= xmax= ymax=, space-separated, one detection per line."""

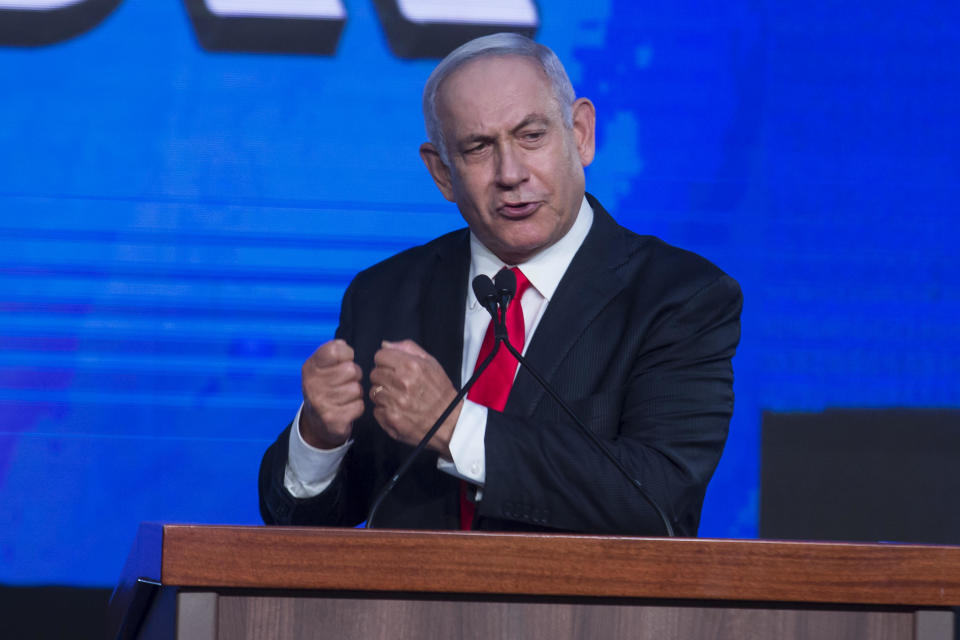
xmin=419 ymin=230 xmax=470 ymax=387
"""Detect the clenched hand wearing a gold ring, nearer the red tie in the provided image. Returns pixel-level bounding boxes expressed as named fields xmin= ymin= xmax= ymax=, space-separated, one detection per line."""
xmin=370 ymin=340 xmax=463 ymax=460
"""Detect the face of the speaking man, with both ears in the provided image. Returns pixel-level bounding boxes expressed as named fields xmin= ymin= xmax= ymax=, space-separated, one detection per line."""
xmin=421 ymin=56 xmax=594 ymax=264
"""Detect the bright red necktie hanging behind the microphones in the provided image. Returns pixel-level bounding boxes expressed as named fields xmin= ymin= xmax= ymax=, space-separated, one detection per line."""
xmin=460 ymin=267 xmax=530 ymax=530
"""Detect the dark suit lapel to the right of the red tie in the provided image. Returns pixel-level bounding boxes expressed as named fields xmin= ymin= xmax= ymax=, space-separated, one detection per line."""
xmin=504 ymin=194 xmax=628 ymax=416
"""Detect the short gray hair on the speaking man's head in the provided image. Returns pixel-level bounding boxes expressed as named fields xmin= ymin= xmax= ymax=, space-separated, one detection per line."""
xmin=423 ymin=33 xmax=576 ymax=165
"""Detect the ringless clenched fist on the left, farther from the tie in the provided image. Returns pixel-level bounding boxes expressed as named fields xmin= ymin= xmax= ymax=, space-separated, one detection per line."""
xmin=300 ymin=339 xmax=363 ymax=449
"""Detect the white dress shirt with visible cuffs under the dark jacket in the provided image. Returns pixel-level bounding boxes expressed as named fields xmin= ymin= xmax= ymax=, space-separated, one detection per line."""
xmin=284 ymin=198 xmax=593 ymax=498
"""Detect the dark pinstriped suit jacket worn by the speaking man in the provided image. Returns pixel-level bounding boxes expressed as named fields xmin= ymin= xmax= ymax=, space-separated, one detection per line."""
xmin=260 ymin=196 xmax=742 ymax=536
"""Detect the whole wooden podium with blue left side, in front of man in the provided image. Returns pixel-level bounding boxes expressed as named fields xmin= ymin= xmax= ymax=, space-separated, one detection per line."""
xmin=110 ymin=524 xmax=960 ymax=640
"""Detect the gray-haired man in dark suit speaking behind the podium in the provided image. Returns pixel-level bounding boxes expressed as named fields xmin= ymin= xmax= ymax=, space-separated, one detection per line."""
xmin=260 ymin=34 xmax=741 ymax=535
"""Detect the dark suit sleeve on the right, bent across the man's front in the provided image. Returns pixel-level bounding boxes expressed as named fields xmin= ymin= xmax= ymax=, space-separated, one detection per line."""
xmin=478 ymin=275 xmax=742 ymax=536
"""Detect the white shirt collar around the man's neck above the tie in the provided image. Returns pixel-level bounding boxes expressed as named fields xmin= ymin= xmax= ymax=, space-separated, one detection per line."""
xmin=468 ymin=196 xmax=593 ymax=309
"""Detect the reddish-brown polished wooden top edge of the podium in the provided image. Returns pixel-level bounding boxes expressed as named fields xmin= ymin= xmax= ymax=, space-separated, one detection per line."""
xmin=124 ymin=525 xmax=960 ymax=607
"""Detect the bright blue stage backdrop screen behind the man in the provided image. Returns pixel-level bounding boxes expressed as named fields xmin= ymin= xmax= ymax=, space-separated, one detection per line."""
xmin=0 ymin=0 xmax=960 ymax=585
